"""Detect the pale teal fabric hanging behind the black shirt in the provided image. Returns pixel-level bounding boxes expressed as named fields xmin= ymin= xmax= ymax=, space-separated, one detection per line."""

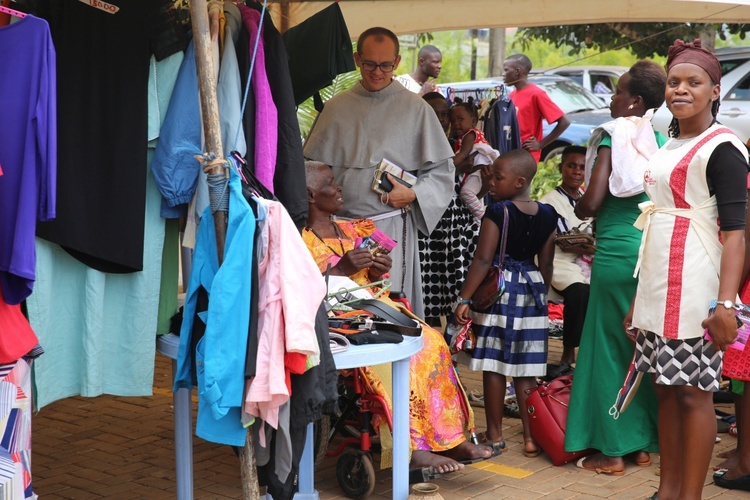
xmin=27 ymin=150 xmax=164 ymax=408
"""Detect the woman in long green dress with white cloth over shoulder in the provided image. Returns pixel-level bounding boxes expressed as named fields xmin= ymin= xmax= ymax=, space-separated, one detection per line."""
xmin=565 ymin=61 xmax=666 ymax=475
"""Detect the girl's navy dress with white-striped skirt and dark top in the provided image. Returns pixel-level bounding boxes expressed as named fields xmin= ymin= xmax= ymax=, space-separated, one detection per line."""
xmin=469 ymin=201 xmax=557 ymax=377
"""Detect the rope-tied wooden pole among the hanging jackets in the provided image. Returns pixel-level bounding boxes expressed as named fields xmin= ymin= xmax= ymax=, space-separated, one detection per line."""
xmin=190 ymin=0 xmax=260 ymax=500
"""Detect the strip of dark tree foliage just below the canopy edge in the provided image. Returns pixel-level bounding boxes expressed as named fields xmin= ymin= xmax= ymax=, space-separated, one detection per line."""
xmin=516 ymin=23 xmax=750 ymax=59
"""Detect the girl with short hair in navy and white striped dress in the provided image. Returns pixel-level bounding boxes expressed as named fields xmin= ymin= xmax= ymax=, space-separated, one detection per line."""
xmin=456 ymin=149 xmax=557 ymax=457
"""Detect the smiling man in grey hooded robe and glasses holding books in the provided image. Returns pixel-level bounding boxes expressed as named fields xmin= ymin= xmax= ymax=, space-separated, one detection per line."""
xmin=304 ymin=28 xmax=455 ymax=317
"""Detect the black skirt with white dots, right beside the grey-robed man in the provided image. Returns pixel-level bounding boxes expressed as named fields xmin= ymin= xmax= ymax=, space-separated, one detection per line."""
xmin=419 ymin=196 xmax=479 ymax=318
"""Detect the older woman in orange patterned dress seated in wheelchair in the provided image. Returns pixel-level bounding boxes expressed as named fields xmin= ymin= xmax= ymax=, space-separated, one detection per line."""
xmin=302 ymin=161 xmax=499 ymax=474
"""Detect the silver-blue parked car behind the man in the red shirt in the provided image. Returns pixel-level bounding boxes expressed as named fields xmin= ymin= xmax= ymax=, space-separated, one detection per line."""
xmin=438 ymin=75 xmax=611 ymax=160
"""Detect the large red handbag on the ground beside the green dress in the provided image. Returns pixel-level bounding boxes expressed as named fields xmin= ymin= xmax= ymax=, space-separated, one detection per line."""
xmin=526 ymin=375 xmax=594 ymax=465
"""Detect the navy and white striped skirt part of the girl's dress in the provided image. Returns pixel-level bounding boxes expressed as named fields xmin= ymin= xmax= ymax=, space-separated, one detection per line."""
xmin=469 ymin=258 xmax=549 ymax=377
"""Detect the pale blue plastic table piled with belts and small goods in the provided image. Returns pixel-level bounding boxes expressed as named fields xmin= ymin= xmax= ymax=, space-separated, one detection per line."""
xmin=156 ymin=334 xmax=422 ymax=500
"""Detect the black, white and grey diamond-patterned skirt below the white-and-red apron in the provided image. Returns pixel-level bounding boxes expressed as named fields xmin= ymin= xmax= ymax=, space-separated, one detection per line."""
xmin=635 ymin=330 xmax=724 ymax=392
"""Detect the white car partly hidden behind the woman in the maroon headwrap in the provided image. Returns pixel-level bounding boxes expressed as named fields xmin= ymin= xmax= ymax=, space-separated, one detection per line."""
xmin=652 ymin=47 xmax=750 ymax=147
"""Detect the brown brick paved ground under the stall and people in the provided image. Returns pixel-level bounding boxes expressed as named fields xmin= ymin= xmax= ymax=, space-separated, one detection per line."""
xmin=32 ymin=340 xmax=750 ymax=500
